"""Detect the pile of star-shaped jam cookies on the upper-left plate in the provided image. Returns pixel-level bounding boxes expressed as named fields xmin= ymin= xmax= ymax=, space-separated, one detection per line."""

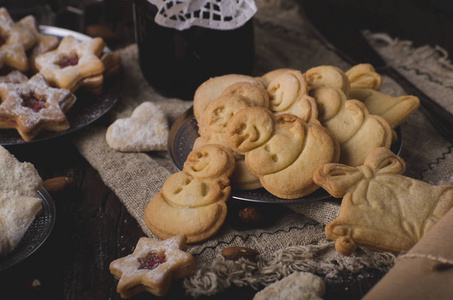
xmin=0 ymin=7 xmax=120 ymax=141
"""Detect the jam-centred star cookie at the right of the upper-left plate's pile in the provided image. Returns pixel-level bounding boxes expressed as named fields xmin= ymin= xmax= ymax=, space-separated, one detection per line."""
xmin=35 ymin=35 xmax=105 ymax=92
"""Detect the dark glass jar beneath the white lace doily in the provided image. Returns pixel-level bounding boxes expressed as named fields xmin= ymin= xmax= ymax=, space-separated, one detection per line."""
xmin=133 ymin=0 xmax=254 ymax=100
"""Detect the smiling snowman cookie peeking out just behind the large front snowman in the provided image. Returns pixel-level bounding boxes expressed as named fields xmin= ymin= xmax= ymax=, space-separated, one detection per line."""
xmin=267 ymin=70 xmax=318 ymax=122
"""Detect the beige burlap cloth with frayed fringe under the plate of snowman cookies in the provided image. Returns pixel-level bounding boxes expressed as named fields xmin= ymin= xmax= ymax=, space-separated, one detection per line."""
xmin=74 ymin=1 xmax=453 ymax=296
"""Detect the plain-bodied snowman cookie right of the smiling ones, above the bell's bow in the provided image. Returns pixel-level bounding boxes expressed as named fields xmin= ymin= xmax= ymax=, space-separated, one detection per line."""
xmin=310 ymin=87 xmax=393 ymax=166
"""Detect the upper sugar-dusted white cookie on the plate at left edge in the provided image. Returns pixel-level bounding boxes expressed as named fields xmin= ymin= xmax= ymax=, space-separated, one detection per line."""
xmin=0 ymin=146 xmax=42 ymax=197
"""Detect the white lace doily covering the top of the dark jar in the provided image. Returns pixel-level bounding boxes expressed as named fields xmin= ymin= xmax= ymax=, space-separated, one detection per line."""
xmin=148 ymin=0 xmax=257 ymax=30
